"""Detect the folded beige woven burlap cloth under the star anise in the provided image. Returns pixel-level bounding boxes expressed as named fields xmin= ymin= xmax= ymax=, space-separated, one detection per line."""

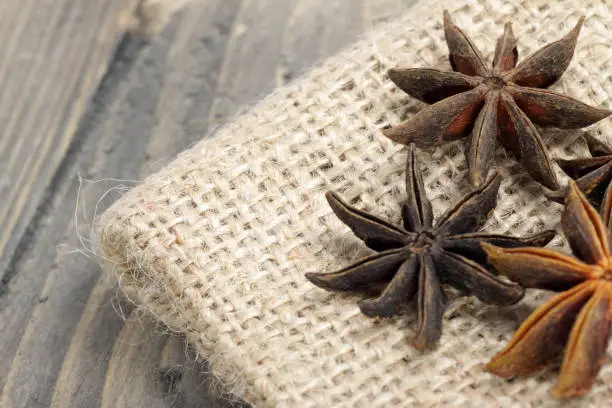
xmin=99 ymin=0 xmax=612 ymax=408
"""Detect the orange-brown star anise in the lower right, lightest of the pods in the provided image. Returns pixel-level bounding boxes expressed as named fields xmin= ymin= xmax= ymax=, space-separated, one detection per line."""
xmin=483 ymin=181 xmax=612 ymax=398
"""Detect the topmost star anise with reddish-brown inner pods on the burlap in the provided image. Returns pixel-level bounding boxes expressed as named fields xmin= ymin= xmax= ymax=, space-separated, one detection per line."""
xmin=383 ymin=11 xmax=611 ymax=190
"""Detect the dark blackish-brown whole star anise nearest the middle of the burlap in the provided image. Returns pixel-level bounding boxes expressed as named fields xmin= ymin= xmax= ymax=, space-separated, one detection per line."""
xmin=306 ymin=144 xmax=554 ymax=349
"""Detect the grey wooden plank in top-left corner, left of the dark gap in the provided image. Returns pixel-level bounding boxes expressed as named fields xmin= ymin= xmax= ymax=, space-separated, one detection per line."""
xmin=0 ymin=0 xmax=135 ymax=291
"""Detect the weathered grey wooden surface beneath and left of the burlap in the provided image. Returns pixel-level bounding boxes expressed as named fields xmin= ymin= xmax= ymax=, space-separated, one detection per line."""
xmin=0 ymin=0 xmax=414 ymax=408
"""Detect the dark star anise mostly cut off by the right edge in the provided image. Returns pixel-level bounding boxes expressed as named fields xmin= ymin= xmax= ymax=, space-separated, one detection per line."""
xmin=548 ymin=134 xmax=612 ymax=228
